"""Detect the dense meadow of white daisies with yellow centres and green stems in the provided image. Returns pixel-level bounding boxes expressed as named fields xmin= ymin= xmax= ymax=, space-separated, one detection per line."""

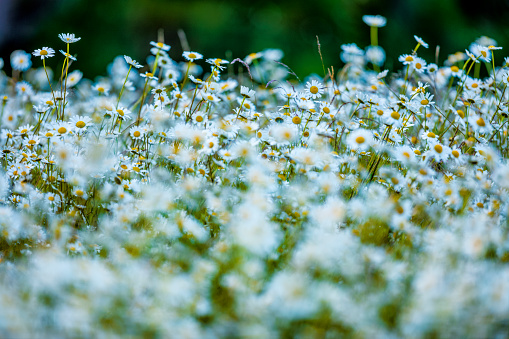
xmin=0 ymin=16 xmax=509 ymax=338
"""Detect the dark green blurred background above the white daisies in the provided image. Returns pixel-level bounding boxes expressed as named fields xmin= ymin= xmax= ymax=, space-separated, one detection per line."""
xmin=0 ymin=0 xmax=509 ymax=79
